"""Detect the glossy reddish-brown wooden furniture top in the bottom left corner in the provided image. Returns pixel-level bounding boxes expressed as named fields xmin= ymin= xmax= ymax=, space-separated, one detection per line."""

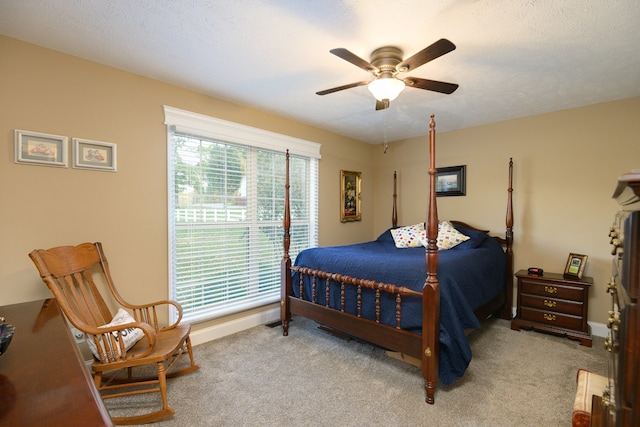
xmin=0 ymin=299 xmax=113 ymax=427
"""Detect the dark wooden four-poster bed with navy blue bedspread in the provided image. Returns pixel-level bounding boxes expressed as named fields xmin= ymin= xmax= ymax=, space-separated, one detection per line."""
xmin=280 ymin=115 xmax=513 ymax=404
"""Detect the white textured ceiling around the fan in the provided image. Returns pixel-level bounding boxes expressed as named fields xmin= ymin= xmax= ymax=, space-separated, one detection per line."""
xmin=0 ymin=0 xmax=640 ymax=144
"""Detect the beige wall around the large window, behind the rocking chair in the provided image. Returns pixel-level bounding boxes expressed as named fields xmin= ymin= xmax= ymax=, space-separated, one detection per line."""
xmin=0 ymin=37 xmax=374 ymax=332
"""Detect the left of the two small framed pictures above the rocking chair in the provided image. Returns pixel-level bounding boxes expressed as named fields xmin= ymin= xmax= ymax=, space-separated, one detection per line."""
xmin=14 ymin=129 xmax=69 ymax=168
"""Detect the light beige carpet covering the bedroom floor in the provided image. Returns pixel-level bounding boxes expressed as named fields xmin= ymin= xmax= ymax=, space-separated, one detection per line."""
xmin=107 ymin=317 xmax=607 ymax=427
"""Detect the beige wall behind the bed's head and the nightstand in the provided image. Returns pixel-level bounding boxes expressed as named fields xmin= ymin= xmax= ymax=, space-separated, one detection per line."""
xmin=374 ymin=98 xmax=640 ymax=323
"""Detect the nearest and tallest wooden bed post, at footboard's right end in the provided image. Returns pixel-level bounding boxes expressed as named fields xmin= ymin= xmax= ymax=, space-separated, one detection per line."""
xmin=422 ymin=114 xmax=440 ymax=404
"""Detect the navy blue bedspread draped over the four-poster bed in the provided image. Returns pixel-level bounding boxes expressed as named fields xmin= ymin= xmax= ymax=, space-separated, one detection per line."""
xmin=293 ymin=229 xmax=506 ymax=384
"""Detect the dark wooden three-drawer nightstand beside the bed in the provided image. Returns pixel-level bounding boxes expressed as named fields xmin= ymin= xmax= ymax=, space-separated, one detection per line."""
xmin=511 ymin=270 xmax=593 ymax=347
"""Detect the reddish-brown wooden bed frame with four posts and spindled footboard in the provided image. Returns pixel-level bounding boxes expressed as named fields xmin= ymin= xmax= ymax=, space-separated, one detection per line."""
xmin=280 ymin=115 xmax=513 ymax=404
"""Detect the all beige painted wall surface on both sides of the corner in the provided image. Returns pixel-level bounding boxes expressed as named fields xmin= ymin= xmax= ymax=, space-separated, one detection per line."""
xmin=0 ymin=37 xmax=640 ymax=332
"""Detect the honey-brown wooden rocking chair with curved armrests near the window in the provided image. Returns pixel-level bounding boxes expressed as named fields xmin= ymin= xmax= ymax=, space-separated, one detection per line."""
xmin=29 ymin=243 xmax=199 ymax=424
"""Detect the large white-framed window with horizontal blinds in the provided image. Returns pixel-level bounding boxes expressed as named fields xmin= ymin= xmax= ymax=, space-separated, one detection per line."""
xmin=165 ymin=107 xmax=320 ymax=322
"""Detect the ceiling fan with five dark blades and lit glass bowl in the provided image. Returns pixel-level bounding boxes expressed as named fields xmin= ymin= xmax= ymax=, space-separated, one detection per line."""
xmin=316 ymin=39 xmax=458 ymax=110
